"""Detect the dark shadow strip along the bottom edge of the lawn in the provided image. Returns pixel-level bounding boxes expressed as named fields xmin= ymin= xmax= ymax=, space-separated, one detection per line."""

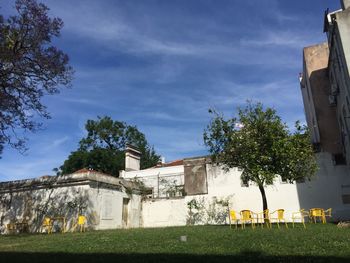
xmin=0 ymin=251 xmax=350 ymax=263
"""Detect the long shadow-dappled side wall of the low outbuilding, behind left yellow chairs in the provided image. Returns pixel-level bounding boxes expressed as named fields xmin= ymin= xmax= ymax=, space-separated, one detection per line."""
xmin=0 ymin=185 xmax=95 ymax=232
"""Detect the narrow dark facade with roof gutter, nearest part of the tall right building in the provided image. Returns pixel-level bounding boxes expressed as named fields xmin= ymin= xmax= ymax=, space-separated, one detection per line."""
xmin=324 ymin=0 xmax=350 ymax=165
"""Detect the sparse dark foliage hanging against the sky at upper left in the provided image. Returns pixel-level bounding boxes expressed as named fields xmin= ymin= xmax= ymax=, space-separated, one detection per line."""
xmin=0 ymin=0 xmax=73 ymax=154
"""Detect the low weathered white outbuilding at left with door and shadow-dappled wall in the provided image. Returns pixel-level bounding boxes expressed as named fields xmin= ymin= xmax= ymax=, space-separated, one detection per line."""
xmin=0 ymin=174 xmax=141 ymax=232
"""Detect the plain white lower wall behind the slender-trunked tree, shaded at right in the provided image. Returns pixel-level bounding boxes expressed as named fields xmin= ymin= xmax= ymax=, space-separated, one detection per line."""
xmin=127 ymin=156 xmax=350 ymax=227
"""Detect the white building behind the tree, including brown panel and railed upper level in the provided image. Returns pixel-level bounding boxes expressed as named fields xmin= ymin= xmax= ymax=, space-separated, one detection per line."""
xmin=120 ymin=153 xmax=350 ymax=227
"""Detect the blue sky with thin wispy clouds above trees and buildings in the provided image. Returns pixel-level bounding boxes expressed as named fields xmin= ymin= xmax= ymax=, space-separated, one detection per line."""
xmin=0 ymin=0 xmax=340 ymax=181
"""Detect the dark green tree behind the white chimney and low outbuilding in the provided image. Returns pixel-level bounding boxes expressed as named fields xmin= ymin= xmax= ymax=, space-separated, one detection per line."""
xmin=58 ymin=117 xmax=160 ymax=176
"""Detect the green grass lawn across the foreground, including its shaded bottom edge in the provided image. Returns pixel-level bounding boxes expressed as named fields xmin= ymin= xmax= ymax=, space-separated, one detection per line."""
xmin=0 ymin=224 xmax=350 ymax=263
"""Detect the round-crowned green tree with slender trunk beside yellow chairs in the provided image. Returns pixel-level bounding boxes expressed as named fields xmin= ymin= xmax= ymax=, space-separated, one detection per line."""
xmin=204 ymin=102 xmax=317 ymax=210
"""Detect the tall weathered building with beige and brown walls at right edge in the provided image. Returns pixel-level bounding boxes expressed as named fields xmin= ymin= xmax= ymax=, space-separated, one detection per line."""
xmin=300 ymin=0 xmax=350 ymax=209
